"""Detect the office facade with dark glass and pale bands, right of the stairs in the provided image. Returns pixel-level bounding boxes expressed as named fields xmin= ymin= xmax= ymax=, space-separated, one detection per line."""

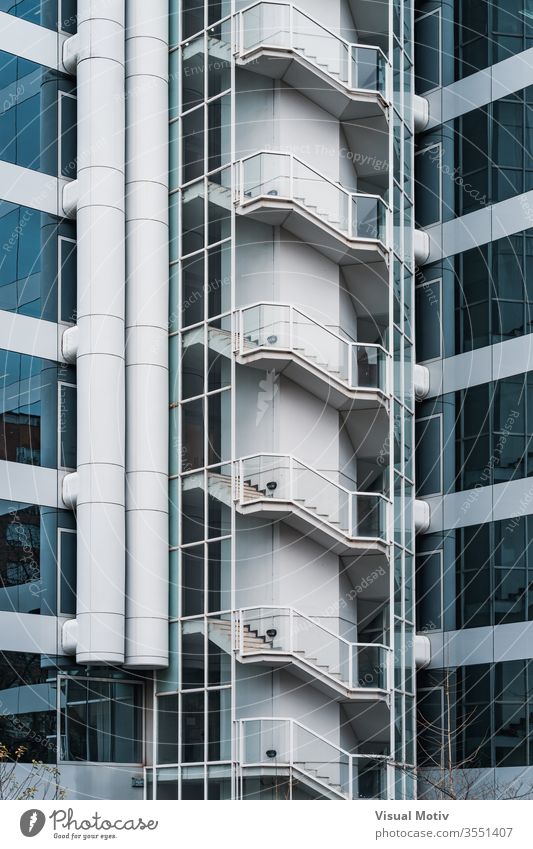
xmin=415 ymin=2 xmax=533 ymax=798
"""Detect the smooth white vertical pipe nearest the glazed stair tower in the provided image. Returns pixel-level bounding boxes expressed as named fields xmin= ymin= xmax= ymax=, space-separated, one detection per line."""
xmin=125 ymin=0 xmax=168 ymax=669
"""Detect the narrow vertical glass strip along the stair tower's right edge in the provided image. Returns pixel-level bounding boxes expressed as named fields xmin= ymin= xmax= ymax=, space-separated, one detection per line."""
xmin=390 ymin=0 xmax=415 ymax=799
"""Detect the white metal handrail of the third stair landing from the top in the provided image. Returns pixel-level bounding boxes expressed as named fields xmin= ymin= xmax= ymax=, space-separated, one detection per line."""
xmin=236 ymin=301 xmax=390 ymax=394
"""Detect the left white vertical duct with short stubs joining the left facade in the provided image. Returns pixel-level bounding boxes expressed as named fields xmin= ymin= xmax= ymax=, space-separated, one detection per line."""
xmin=63 ymin=0 xmax=125 ymax=664
